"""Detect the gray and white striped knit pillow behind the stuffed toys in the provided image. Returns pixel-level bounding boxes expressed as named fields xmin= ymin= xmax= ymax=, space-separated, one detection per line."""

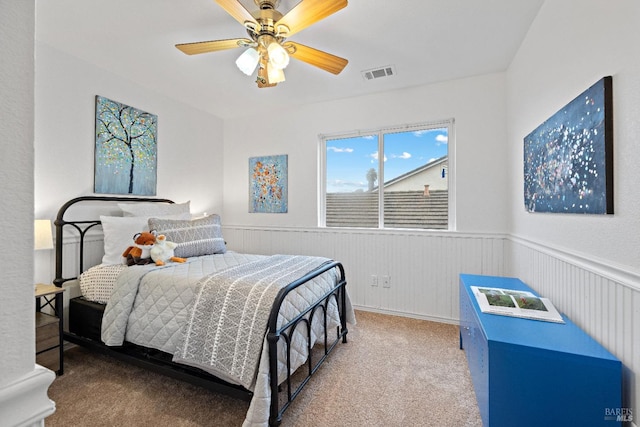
xmin=149 ymin=214 xmax=227 ymax=258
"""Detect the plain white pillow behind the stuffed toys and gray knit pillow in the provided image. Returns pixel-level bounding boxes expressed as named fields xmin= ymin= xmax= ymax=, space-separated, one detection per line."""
xmin=100 ymin=212 xmax=191 ymax=264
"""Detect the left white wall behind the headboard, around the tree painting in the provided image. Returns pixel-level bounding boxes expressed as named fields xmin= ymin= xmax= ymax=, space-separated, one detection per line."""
xmin=35 ymin=40 xmax=223 ymax=218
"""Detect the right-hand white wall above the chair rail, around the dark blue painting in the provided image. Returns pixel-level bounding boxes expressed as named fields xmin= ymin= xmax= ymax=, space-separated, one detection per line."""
xmin=507 ymin=0 xmax=640 ymax=272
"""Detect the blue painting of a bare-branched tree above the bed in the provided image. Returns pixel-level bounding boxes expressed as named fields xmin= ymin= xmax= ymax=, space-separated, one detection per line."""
xmin=94 ymin=96 xmax=158 ymax=196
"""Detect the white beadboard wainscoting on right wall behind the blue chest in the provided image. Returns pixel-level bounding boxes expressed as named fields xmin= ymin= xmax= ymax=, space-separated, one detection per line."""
xmin=505 ymin=237 xmax=640 ymax=425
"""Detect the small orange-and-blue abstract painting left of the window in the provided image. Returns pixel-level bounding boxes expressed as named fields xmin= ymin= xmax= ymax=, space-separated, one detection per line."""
xmin=249 ymin=154 xmax=288 ymax=213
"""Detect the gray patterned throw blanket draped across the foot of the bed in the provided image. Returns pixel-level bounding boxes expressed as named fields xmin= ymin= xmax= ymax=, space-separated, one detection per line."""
xmin=173 ymin=255 xmax=329 ymax=389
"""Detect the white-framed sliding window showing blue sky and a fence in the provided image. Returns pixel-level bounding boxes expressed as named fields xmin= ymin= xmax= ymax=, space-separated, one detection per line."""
xmin=319 ymin=120 xmax=453 ymax=230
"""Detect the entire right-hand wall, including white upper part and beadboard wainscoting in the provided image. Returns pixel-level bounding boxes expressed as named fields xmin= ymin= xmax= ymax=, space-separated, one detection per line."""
xmin=505 ymin=0 xmax=640 ymax=425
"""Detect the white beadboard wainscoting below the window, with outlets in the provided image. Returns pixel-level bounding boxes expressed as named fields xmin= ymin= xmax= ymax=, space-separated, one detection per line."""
xmin=223 ymin=226 xmax=505 ymax=323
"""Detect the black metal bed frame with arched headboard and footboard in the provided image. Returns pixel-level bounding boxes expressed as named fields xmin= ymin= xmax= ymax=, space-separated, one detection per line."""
xmin=53 ymin=196 xmax=348 ymax=425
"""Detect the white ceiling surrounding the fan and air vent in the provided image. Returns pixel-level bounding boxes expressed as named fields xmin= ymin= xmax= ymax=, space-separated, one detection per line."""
xmin=36 ymin=0 xmax=544 ymax=119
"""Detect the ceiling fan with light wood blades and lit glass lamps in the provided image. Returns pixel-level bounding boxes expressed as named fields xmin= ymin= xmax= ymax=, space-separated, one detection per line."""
xmin=176 ymin=0 xmax=349 ymax=88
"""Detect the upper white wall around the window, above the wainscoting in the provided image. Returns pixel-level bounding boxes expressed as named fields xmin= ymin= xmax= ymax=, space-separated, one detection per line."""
xmin=222 ymin=73 xmax=507 ymax=232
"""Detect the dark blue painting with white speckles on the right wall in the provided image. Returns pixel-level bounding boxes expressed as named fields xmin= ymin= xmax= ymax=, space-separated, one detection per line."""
xmin=524 ymin=77 xmax=613 ymax=214
